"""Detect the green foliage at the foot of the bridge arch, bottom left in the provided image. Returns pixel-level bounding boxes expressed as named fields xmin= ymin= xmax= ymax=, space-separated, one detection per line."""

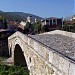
xmin=0 ymin=65 xmax=29 ymax=75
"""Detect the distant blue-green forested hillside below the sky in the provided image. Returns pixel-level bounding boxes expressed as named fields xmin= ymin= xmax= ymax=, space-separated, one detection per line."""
xmin=0 ymin=11 xmax=43 ymax=21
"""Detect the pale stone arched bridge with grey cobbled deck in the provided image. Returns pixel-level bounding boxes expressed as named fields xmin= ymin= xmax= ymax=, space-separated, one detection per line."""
xmin=8 ymin=30 xmax=75 ymax=75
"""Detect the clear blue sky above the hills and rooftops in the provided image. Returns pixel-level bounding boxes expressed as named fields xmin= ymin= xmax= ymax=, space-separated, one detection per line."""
xmin=0 ymin=0 xmax=75 ymax=18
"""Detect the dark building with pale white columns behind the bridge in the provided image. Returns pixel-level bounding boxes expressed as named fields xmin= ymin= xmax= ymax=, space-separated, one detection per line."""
xmin=41 ymin=17 xmax=63 ymax=29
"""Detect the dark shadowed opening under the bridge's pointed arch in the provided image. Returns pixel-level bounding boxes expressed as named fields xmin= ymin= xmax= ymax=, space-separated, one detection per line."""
xmin=14 ymin=44 xmax=27 ymax=67
